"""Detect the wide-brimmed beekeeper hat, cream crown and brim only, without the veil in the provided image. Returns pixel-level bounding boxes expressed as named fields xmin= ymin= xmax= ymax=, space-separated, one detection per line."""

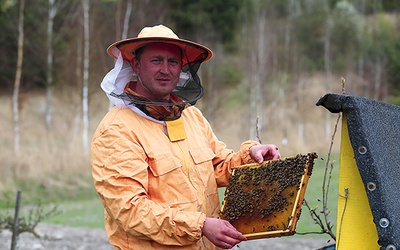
xmin=107 ymin=25 xmax=212 ymax=66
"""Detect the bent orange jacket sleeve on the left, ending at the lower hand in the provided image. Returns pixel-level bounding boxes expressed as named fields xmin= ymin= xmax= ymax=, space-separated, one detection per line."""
xmin=91 ymin=125 xmax=206 ymax=245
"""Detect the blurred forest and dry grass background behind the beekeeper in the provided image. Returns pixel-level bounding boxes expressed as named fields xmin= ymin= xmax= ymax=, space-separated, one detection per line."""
xmin=0 ymin=0 xmax=400 ymax=233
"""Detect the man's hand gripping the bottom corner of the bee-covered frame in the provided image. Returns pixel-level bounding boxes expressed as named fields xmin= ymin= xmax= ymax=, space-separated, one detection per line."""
xmin=203 ymin=218 xmax=246 ymax=249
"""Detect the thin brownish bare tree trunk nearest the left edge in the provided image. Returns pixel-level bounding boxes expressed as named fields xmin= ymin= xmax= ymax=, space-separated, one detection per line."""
xmin=13 ymin=0 xmax=25 ymax=153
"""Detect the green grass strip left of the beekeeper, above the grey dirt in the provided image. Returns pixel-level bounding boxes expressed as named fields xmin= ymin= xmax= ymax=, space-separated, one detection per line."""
xmin=0 ymin=177 xmax=104 ymax=227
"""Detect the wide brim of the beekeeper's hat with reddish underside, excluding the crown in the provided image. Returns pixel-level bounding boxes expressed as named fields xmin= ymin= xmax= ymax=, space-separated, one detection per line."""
xmin=107 ymin=37 xmax=212 ymax=65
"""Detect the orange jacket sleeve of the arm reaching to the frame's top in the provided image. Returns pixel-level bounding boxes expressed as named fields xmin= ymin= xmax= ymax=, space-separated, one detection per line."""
xmin=190 ymin=107 xmax=260 ymax=187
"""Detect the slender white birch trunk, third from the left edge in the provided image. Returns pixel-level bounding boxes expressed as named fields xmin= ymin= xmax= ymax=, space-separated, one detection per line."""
xmin=82 ymin=0 xmax=90 ymax=156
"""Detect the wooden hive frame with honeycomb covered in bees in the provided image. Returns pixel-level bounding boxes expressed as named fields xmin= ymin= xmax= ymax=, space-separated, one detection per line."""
xmin=220 ymin=153 xmax=318 ymax=239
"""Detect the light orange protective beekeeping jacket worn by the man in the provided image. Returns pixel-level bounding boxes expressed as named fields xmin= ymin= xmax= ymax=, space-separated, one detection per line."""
xmin=91 ymin=107 xmax=257 ymax=250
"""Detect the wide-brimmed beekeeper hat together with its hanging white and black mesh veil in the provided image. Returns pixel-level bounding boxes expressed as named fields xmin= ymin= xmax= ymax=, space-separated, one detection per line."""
xmin=101 ymin=25 xmax=212 ymax=107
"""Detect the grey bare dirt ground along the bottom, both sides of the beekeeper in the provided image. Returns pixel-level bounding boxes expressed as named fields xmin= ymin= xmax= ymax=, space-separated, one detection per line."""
xmin=0 ymin=223 xmax=329 ymax=250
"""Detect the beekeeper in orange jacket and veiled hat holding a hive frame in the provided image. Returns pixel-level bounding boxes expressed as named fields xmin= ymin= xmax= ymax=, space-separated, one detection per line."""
xmin=91 ymin=25 xmax=280 ymax=249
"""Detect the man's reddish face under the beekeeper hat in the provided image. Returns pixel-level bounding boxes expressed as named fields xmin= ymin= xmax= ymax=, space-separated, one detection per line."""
xmin=132 ymin=43 xmax=182 ymax=99
